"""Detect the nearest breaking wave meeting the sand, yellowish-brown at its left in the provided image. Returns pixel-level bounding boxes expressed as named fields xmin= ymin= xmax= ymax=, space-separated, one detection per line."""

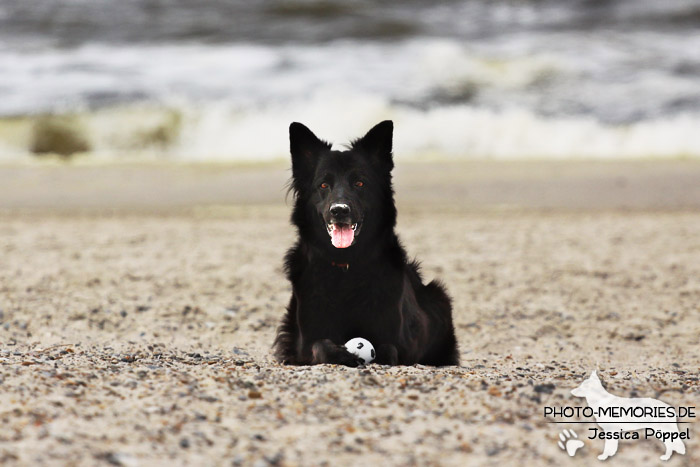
xmin=0 ymin=98 xmax=700 ymax=163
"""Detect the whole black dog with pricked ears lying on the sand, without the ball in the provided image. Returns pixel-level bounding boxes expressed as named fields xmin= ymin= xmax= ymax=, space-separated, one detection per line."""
xmin=274 ymin=121 xmax=459 ymax=366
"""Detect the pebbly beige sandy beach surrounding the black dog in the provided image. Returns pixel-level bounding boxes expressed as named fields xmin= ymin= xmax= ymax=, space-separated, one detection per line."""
xmin=0 ymin=160 xmax=700 ymax=466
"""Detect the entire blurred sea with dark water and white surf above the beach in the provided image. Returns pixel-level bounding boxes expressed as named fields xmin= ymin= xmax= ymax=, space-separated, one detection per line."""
xmin=0 ymin=0 xmax=700 ymax=162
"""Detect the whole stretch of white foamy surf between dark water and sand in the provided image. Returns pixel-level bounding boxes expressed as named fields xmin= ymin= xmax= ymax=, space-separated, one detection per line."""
xmin=0 ymin=32 xmax=700 ymax=161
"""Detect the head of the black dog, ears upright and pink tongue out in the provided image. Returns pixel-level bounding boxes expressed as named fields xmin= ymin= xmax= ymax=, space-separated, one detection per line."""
xmin=289 ymin=121 xmax=396 ymax=248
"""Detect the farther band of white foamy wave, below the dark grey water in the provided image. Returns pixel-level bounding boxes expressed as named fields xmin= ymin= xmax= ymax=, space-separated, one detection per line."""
xmin=5 ymin=32 xmax=700 ymax=123
